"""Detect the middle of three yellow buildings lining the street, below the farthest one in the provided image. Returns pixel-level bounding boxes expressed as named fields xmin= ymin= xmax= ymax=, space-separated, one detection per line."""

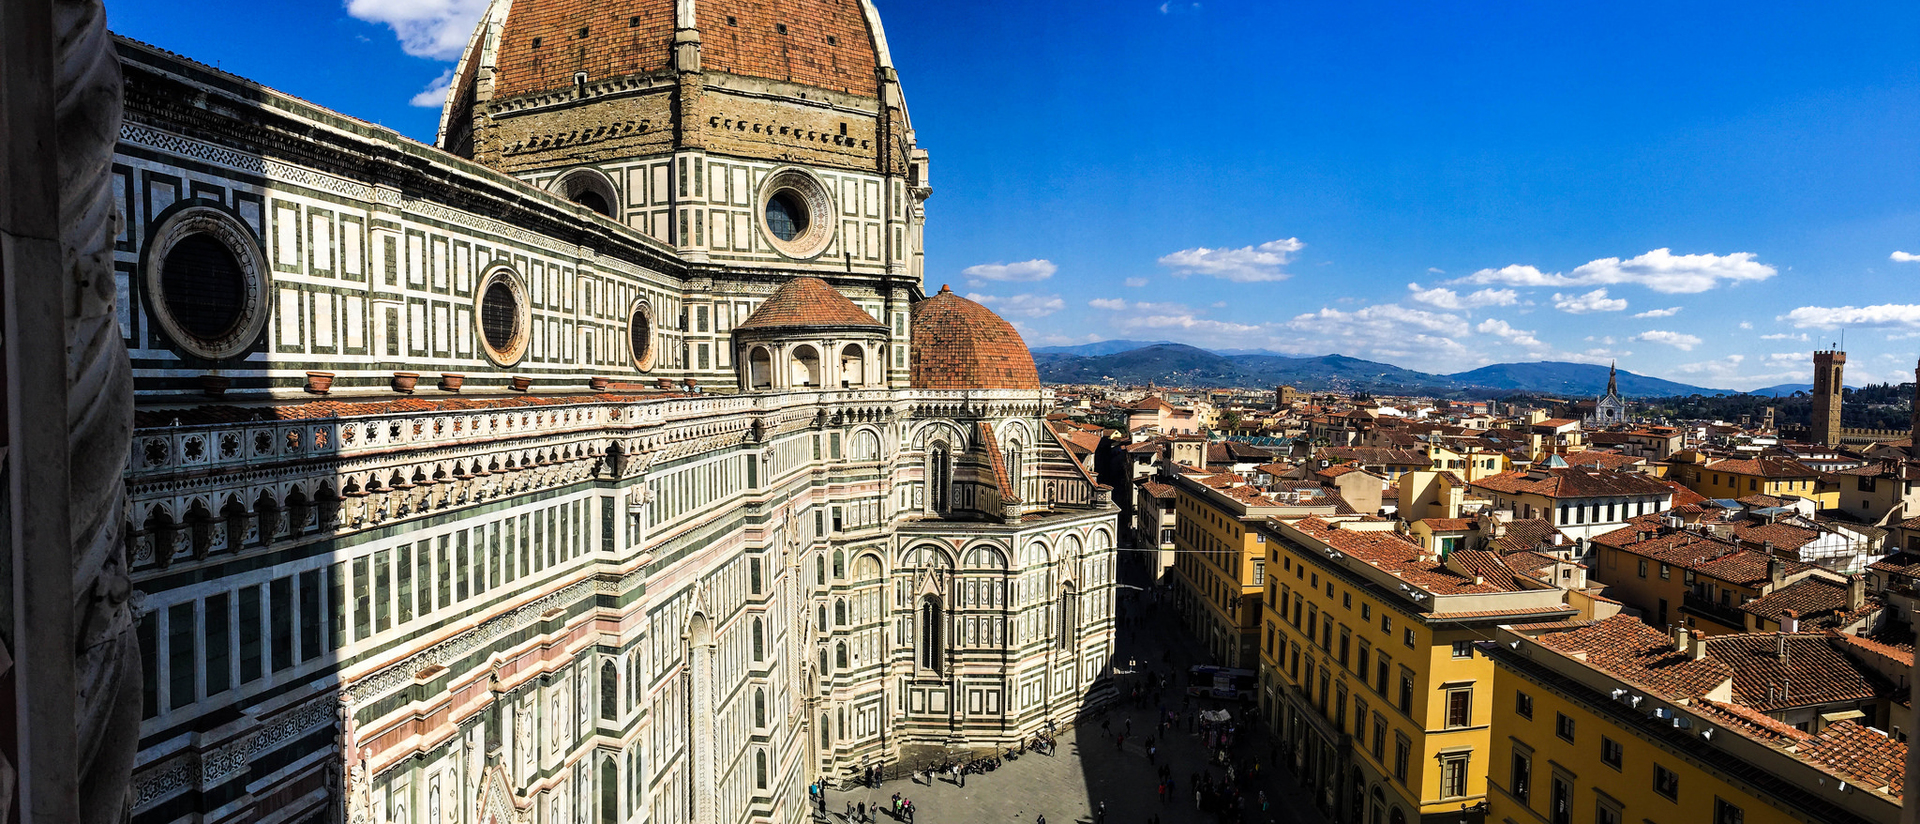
xmin=1260 ymin=519 xmax=1576 ymax=824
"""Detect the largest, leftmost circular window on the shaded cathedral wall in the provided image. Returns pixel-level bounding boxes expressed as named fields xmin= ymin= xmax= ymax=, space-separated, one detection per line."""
xmin=144 ymin=206 xmax=267 ymax=361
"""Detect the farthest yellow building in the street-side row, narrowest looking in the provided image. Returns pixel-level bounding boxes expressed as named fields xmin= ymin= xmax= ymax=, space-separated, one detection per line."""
xmin=1171 ymin=473 xmax=1340 ymax=668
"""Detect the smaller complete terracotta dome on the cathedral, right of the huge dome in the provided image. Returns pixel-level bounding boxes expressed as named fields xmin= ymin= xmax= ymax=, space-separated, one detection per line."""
xmin=914 ymin=286 xmax=1041 ymax=390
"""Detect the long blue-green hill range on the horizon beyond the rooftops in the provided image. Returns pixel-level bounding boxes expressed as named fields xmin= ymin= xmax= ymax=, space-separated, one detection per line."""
xmin=1033 ymin=340 xmax=1726 ymax=398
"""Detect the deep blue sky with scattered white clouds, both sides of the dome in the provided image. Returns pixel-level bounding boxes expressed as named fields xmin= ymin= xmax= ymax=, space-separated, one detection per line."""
xmin=108 ymin=0 xmax=1920 ymax=388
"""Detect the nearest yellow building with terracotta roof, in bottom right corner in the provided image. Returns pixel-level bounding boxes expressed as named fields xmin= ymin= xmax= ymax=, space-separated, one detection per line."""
xmin=1484 ymin=617 xmax=1907 ymax=824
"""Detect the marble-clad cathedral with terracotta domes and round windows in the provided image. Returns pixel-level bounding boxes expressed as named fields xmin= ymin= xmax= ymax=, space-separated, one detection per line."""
xmin=111 ymin=0 xmax=1117 ymax=824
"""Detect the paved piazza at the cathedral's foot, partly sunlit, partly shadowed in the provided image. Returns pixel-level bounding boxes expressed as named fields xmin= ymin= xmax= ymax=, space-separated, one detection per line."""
xmin=814 ymin=569 xmax=1325 ymax=824
